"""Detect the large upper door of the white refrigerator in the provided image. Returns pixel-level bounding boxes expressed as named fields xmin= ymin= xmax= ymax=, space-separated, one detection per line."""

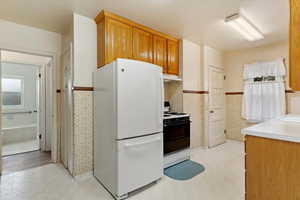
xmin=116 ymin=59 xmax=163 ymax=139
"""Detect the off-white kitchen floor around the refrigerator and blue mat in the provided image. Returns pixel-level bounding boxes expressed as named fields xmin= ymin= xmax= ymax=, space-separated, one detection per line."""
xmin=0 ymin=141 xmax=244 ymax=200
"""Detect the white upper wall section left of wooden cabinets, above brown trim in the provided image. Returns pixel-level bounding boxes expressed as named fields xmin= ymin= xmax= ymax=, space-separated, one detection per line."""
xmin=73 ymin=13 xmax=97 ymax=87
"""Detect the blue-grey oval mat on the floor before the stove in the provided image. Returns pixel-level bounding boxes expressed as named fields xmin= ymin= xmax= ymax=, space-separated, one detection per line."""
xmin=164 ymin=160 xmax=205 ymax=181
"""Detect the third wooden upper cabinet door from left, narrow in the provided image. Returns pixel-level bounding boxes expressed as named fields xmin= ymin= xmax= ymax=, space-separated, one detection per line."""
xmin=153 ymin=35 xmax=167 ymax=73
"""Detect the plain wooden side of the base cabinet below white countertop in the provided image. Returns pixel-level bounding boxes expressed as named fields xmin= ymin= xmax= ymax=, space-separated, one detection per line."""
xmin=245 ymin=135 xmax=300 ymax=200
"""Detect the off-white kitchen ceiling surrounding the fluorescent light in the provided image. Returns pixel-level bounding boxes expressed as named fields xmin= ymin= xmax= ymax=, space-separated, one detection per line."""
xmin=0 ymin=0 xmax=289 ymax=50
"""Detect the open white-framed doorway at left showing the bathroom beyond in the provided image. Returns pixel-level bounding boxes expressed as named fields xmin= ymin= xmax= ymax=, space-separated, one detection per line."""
xmin=0 ymin=50 xmax=52 ymax=174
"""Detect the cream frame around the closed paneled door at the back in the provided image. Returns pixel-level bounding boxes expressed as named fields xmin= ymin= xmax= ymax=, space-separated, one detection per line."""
xmin=206 ymin=65 xmax=226 ymax=148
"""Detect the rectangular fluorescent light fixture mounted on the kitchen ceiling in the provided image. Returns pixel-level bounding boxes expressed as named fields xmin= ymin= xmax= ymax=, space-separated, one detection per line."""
xmin=225 ymin=13 xmax=264 ymax=41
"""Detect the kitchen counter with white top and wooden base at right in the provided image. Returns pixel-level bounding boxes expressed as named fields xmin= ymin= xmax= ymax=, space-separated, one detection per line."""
xmin=242 ymin=115 xmax=300 ymax=200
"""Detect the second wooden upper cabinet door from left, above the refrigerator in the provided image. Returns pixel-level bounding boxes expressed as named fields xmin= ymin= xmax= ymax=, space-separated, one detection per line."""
xmin=132 ymin=28 xmax=153 ymax=63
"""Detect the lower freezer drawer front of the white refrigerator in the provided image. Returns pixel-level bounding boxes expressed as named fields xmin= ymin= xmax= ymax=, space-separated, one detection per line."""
xmin=117 ymin=133 xmax=163 ymax=196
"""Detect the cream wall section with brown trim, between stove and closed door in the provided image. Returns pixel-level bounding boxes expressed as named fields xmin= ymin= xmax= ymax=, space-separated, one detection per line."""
xmin=181 ymin=39 xmax=204 ymax=147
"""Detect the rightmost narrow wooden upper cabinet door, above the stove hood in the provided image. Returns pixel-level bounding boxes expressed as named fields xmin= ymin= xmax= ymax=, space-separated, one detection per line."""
xmin=167 ymin=40 xmax=179 ymax=75
